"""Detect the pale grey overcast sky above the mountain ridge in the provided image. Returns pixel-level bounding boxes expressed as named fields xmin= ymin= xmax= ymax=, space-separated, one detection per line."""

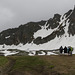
xmin=0 ymin=0 xmax=75 ymax=31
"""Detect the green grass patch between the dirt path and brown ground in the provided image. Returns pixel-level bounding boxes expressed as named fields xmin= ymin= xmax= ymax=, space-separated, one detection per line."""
xmin=13 ymin=56 xmax=46 ymax=70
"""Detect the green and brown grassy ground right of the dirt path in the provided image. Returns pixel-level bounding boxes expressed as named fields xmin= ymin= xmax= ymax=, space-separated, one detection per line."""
xmin=9 ymin=55 xmax=75 ymax=75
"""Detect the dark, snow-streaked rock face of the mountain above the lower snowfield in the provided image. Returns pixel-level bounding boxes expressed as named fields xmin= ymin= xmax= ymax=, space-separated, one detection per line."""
xmin=0 ymin=8 xmax=75 ymax=45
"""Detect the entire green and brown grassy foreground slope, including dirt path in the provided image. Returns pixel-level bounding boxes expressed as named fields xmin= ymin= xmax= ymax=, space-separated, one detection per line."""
xmin=0 ymin=55 xmax=75 ymax=75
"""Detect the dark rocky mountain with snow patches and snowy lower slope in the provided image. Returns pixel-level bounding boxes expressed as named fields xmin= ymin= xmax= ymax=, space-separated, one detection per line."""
xmin=0 ymin=7 xmax=75 ymax=49
